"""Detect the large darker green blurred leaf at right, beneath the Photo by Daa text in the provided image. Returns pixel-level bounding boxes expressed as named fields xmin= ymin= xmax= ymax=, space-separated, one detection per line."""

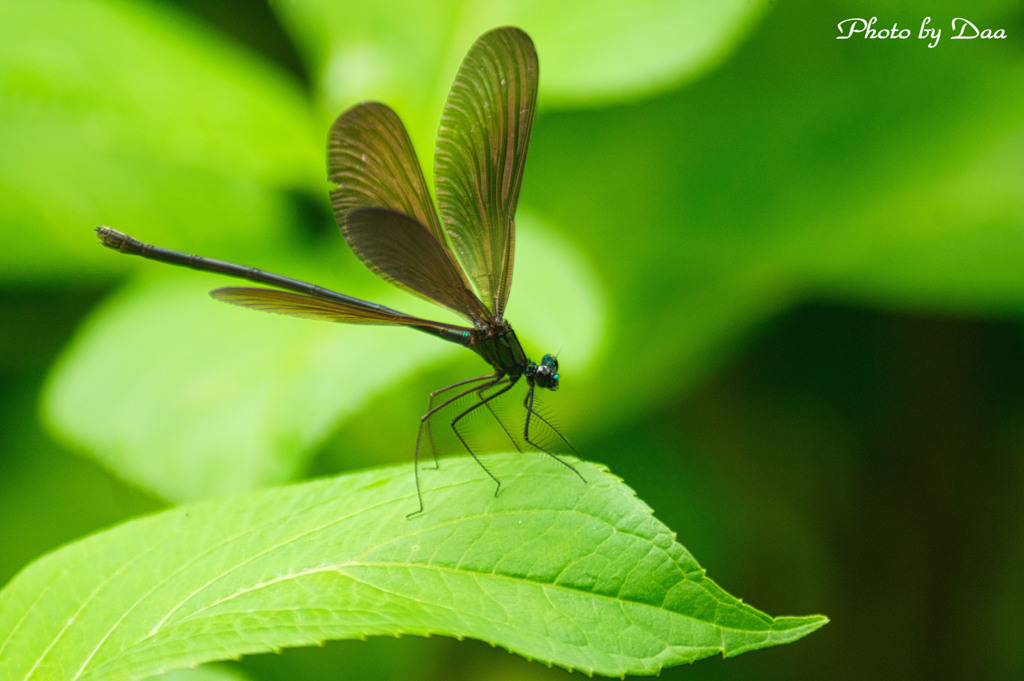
xmin=522 ymin=2 xmax=1024 ymax=425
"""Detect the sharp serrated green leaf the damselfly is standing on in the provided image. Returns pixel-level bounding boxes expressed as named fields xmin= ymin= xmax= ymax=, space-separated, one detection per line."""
xmin=0 ymin=455 xmax=827 ymax=681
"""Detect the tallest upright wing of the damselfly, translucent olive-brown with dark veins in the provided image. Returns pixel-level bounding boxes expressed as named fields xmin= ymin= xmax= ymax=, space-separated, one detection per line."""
xmin=434 ymin=28 xmax=538 ymax=318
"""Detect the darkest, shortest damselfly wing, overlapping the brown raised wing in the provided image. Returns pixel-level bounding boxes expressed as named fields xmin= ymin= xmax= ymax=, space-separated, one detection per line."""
xmin=341 ymin=208 xmax=494 ymax=326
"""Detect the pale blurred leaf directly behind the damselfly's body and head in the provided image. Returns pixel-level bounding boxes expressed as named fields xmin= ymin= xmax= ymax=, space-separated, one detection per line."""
xmin=43 ymin=215 xmax=602 ymax=501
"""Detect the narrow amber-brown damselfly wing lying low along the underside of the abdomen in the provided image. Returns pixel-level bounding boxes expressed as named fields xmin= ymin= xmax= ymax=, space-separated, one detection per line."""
xmin=210 ymin=287 xmax=461 ymax=330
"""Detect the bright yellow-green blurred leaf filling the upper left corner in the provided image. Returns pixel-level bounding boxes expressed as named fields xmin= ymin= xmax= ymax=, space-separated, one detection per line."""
xmin=0 ymin=0 xmax=324 ymax=283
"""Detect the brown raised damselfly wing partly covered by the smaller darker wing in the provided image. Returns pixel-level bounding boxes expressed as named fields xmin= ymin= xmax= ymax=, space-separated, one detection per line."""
xmin=327 ymin=101 xmax=444 ymax=244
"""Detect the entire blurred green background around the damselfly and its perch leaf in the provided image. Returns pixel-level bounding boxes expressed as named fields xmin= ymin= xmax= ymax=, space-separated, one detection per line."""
xmin=0 ymin=0 xmax=1024 ymax=681
